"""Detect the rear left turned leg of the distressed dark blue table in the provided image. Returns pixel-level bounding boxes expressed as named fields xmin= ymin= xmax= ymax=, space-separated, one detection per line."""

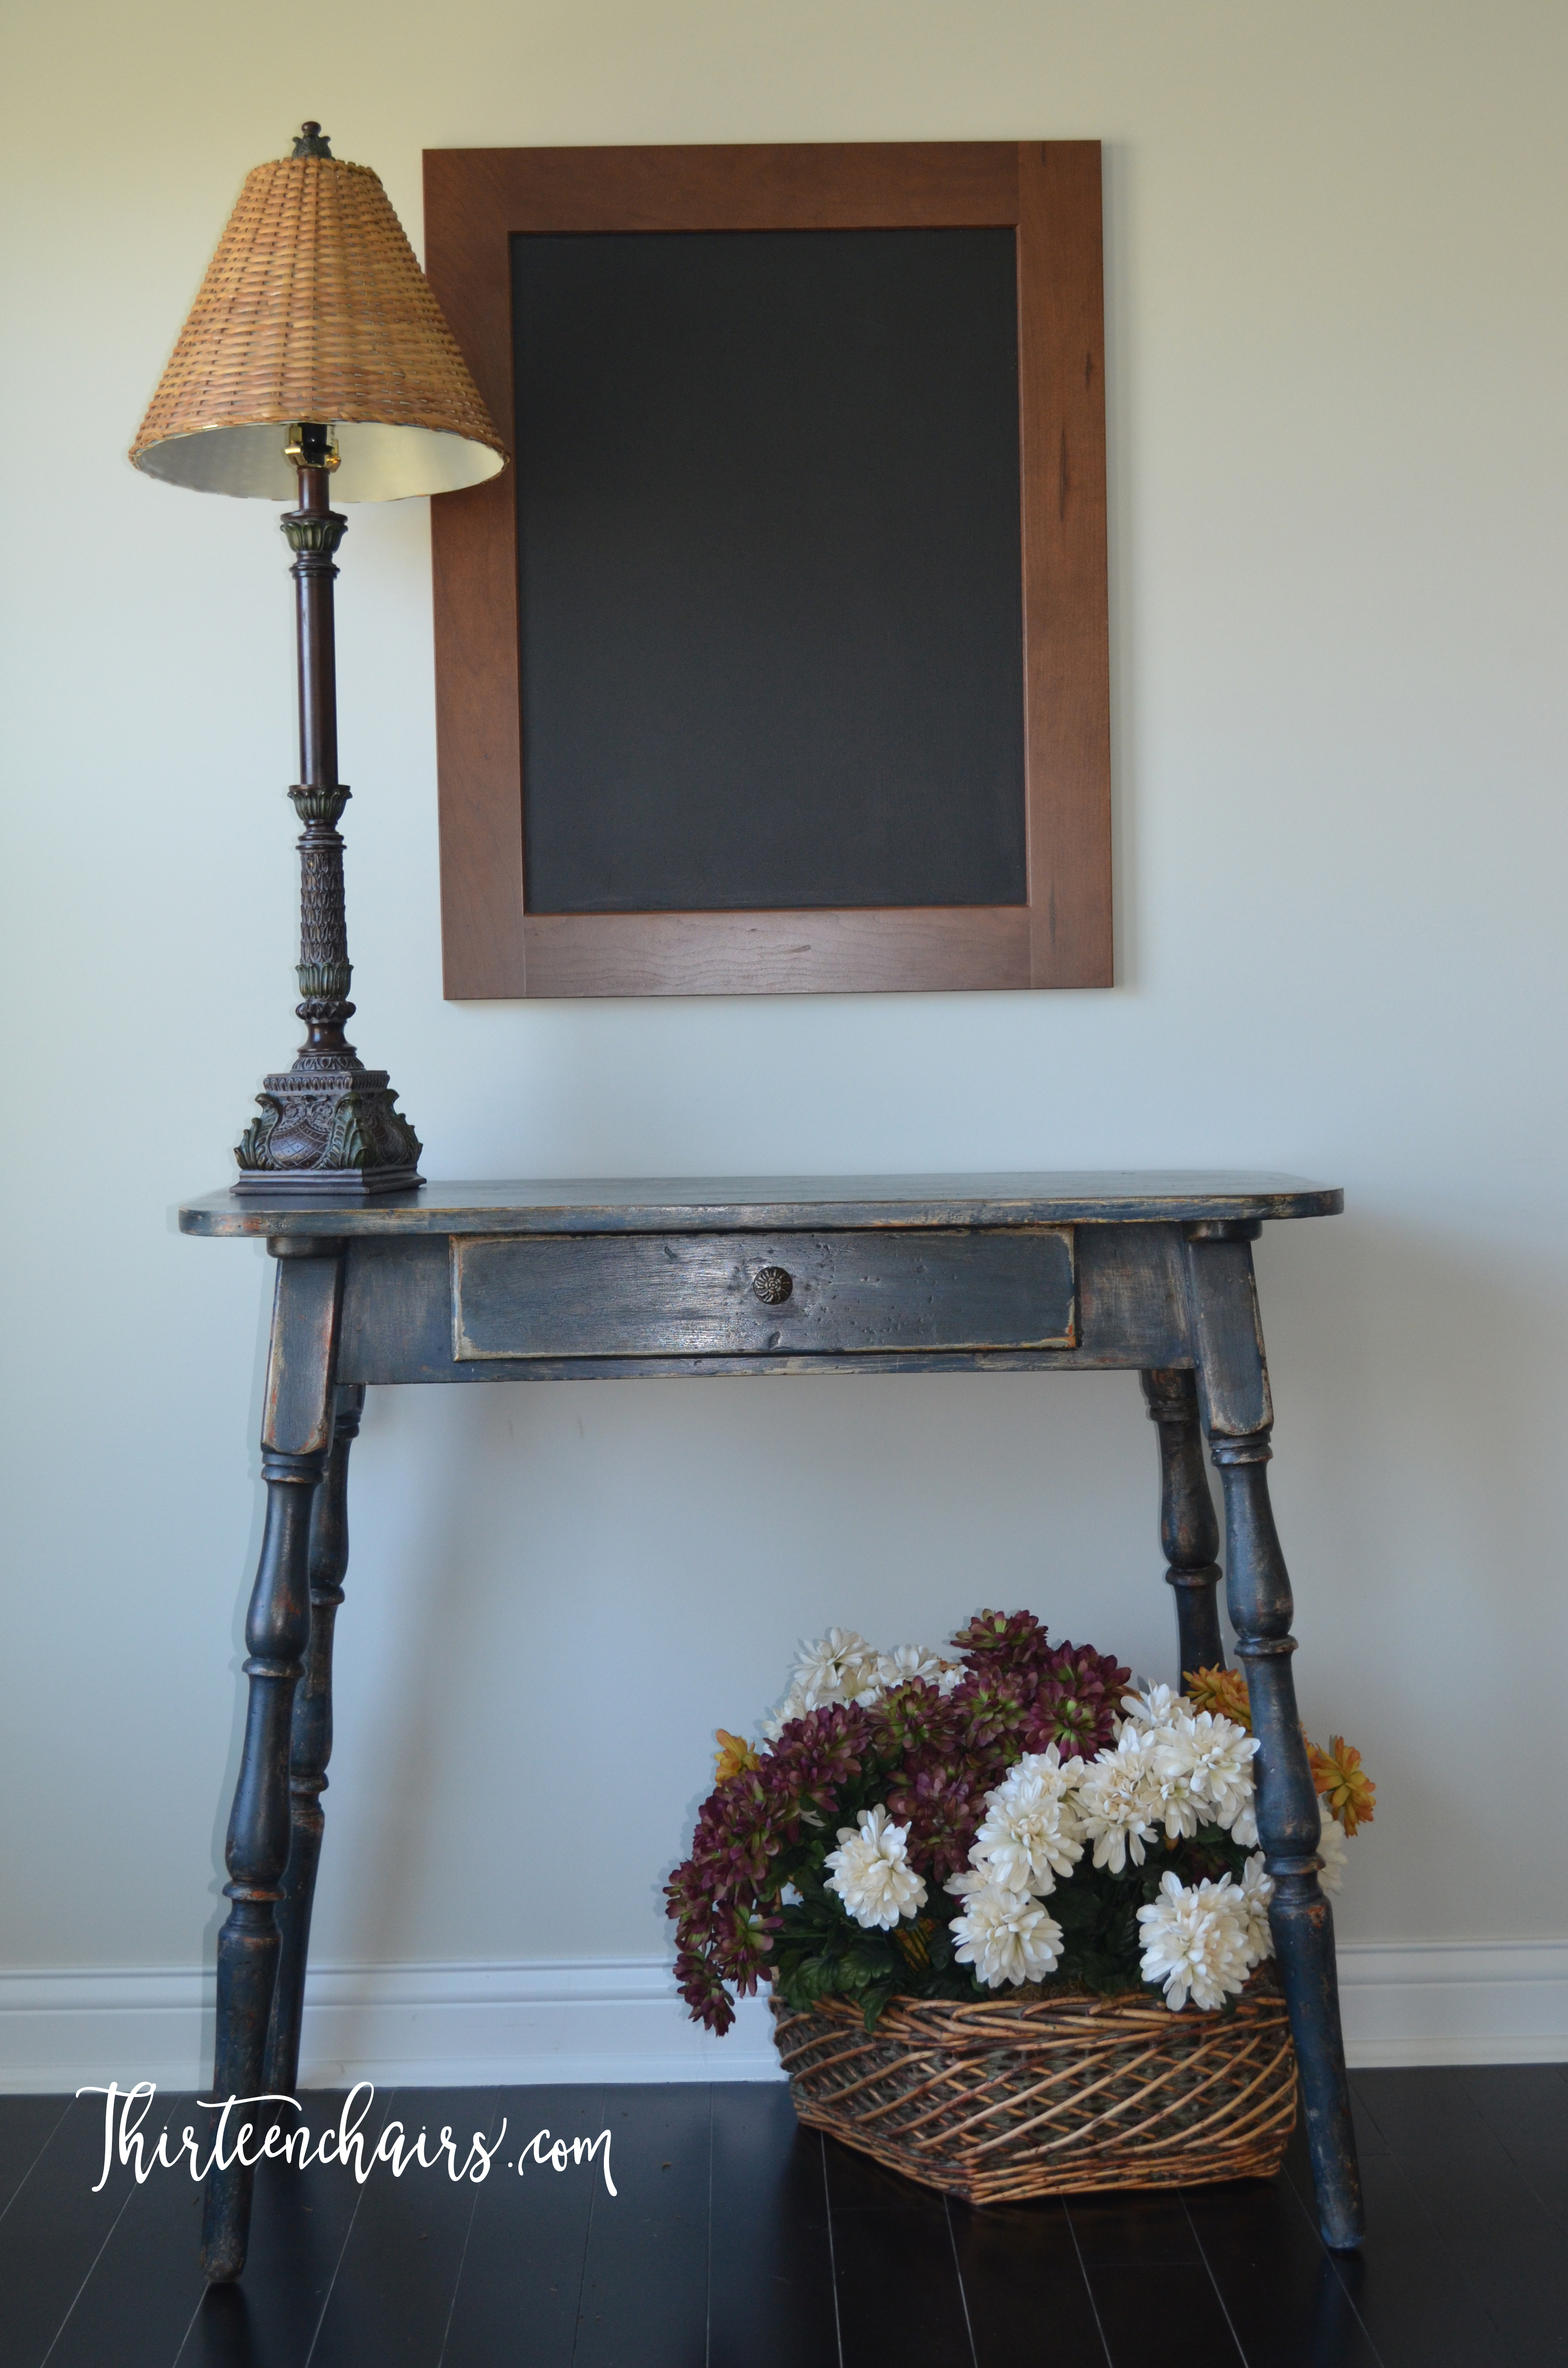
xmin=263 ymin=1383 xmax=365 ymax=2096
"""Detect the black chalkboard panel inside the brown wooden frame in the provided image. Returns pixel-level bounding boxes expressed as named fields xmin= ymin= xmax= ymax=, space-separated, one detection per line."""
xmin=512 ymin=227 xmax=1028 ymax=914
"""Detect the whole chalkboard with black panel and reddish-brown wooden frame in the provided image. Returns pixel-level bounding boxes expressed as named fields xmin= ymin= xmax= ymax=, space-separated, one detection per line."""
xmin=424 ymin=140 xmax=1111 ymax=997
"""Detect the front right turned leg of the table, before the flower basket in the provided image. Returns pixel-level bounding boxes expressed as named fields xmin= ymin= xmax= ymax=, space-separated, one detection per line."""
xmin=1187 ymin=1222 xmax=1367 ymax=2252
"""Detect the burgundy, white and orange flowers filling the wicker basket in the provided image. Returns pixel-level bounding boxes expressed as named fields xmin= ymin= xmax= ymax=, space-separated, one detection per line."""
xmin=665 ymin=1610 xmax=1376 ymax=2032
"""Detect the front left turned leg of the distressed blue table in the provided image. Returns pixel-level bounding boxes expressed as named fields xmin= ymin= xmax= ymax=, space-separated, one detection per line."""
xmin=201 ymin=1238 xmax=343 ymax=2283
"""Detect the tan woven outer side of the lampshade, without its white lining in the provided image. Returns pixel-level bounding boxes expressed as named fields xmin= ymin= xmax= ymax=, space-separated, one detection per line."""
xmin=130 ymin=156 xmax=504 ymax=459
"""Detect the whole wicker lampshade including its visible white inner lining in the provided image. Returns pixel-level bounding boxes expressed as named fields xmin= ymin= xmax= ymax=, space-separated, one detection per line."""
xmin=130 ymin=142 xmax=507 ymax=502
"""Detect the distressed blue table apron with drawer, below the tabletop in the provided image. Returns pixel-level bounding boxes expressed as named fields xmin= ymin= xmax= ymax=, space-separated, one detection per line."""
xmin=339 ymin=1222 xmax=1194 ymax=1383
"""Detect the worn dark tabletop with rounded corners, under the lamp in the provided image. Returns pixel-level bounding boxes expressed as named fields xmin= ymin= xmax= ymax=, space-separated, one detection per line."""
xmin=180 ymin=1168 xmax=1346 ymax=1241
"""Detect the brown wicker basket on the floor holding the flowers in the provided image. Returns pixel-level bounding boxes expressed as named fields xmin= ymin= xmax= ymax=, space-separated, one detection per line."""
xmin=772 ymin=1968 xmax=1296 ymax=2205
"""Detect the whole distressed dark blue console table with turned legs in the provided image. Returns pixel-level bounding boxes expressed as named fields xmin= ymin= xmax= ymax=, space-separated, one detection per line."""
xmin=180 ymin=1174 xmax=1362 ymax=2281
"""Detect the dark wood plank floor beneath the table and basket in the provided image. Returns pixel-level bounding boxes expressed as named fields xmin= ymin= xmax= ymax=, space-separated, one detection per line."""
xmin=0 ymin=2065 xmax=1568 ymax=2368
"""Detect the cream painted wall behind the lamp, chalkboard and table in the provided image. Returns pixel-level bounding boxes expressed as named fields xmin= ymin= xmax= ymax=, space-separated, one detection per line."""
xmin=0 ymin=0 xmax=1568 ymax=2008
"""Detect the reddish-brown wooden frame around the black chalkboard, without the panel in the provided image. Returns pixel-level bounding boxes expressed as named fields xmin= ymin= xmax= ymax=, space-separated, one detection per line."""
xmin=424 ymin=140 xmax=1111 ymax=999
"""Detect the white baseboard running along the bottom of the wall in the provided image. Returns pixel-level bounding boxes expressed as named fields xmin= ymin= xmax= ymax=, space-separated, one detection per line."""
xmin=0 ymin=1939 xmax=1568 ymax=2093
